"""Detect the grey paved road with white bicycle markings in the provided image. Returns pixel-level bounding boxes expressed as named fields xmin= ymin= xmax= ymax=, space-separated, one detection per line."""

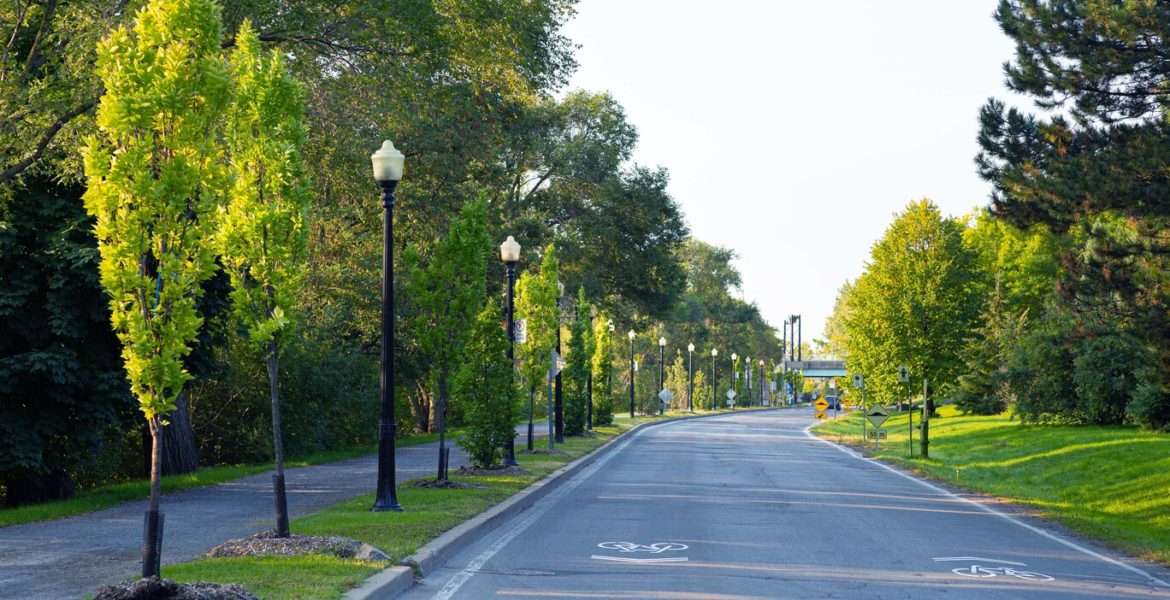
xmin=402 ymin=408 xmax=1170 ymax=600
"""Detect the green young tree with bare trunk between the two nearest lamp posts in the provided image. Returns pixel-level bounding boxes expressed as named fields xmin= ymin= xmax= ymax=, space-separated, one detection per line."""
xmin=407 ymin=196 xmax=491 ymax=481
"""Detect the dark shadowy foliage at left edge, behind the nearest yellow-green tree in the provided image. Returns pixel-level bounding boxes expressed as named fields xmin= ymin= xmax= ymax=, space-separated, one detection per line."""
xmin=0 ymin=177 xmax=135 ymax=504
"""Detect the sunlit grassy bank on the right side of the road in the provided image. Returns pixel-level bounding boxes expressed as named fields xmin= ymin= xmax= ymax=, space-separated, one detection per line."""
xmin=813 ymin=407 xmax=1170 ymax=565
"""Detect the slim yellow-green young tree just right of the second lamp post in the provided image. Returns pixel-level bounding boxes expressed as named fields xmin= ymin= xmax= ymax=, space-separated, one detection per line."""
xmin=516 ymin=246 xmax=560 ymax=447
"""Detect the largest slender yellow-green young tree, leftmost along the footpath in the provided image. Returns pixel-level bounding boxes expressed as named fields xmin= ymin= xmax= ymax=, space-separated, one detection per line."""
xmin=83 ymin=0 xmax=230 ymax=574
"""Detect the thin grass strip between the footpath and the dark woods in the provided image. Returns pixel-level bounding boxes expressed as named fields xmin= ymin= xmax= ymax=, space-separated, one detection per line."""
xmin=0 ymin=434 xmax=449 ymax=527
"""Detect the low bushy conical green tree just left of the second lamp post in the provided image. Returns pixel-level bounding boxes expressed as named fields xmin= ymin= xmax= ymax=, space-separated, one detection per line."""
xmin=453 ymin=299 xmax=519 ymax=468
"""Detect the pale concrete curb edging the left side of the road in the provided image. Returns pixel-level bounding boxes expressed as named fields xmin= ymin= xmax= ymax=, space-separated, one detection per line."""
xmin=344 ymin=407 xmax=787 ymax=600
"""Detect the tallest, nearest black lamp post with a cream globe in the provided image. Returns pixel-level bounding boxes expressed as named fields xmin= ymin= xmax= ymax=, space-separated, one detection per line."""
xmin=370 ymin=139 xmax=406 ymax=511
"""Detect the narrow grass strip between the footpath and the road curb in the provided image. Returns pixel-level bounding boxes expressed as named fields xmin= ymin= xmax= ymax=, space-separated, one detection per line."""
xmin=163 ymin=414 xmax=739 ymax=599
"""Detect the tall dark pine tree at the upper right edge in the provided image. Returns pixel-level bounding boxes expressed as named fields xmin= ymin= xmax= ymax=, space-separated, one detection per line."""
xmin=976 ymin=0 xmax=1170 ymax=428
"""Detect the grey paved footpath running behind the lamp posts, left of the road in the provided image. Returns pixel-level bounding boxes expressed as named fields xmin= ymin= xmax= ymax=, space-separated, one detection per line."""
xmin=0 ymin=423 xmax=548 ymax=600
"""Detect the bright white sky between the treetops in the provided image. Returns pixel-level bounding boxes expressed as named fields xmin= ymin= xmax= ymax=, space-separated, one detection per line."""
xmin=565 ymin=0 xmax=1012 ymax=340
